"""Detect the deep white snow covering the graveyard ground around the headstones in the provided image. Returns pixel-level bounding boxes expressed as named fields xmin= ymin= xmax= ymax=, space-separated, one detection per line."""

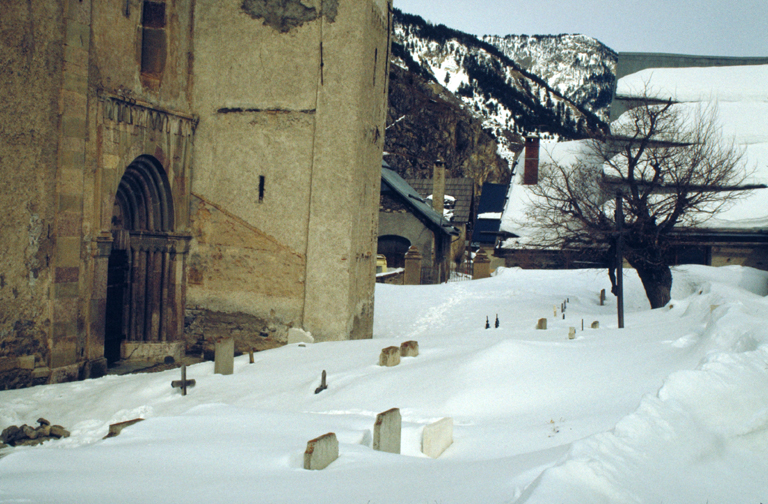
xmin=0 ymin=266 xmax=768 ymax=504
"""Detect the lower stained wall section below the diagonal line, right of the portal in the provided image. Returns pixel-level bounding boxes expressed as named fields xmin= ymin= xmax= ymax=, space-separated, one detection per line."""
xmin=187 ymin=193 xmax=304 ymax=347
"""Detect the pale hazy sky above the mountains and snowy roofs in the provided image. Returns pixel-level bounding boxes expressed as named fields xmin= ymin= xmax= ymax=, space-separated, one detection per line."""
xmin=394 ymin=0 xmax=768 ymax=56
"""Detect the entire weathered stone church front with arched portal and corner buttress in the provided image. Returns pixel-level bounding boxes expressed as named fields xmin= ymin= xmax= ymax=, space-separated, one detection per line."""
xmin=0 ymin=0 xmax=391 ymax=389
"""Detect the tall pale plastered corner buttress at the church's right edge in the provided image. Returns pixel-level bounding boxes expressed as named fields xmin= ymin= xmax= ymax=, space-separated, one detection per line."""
xmin=304 ymin=1 xmax=391 ymax=340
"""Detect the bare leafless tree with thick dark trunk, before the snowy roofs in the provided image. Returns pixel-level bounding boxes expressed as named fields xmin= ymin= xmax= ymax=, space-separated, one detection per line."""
xmin=526 ymin=94 xmax=748 ymax=308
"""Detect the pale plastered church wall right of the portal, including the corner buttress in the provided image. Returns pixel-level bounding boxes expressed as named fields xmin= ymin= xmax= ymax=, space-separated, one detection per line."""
xmin=189 ymin=0 xmax=388 ymax=339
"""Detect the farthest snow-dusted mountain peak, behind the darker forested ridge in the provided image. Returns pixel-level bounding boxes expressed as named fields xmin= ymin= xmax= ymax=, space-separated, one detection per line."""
xmin=482 ymin=35 xmax=617 ymax=120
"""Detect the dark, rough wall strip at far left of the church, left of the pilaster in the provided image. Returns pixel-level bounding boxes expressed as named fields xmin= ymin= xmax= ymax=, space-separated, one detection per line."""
xmin=0 ymin=1 xmax=64 ymax=388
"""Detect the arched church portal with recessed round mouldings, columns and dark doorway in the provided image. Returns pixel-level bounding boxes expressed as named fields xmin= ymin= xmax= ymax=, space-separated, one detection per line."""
xmin=104 ymin=156 xmax=188 ymax=363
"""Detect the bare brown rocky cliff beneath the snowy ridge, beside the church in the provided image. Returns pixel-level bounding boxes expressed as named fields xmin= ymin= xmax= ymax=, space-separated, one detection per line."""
xmin=384 ymin=60 xmax=522 ymax=188
